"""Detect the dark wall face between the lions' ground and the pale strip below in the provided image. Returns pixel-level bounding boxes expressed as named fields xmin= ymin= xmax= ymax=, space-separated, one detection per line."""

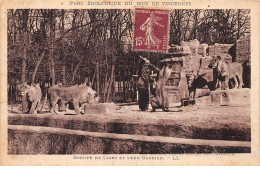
xmin=8 ymin=114 xmax=251 ymax=141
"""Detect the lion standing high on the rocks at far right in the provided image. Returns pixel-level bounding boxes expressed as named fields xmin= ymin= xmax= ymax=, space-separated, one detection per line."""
xmin=209 ymin=56 xmax=243 ymax=90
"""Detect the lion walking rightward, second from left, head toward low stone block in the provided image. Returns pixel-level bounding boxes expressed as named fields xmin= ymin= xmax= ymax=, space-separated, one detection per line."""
xmin=45 ymin=84 xmax=98 ymax=114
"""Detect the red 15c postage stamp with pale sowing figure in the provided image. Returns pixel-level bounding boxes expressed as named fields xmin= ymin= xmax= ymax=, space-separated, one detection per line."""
xmin=133 ymin=8 xmax=169 ymax=52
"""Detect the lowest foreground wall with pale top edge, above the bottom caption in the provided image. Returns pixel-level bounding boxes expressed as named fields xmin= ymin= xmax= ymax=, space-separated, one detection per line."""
xmin=8 ymin=125 xmax=251 ymax=154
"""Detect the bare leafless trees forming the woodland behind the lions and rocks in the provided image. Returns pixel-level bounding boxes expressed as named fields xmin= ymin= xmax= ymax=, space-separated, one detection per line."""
xmin=7 ymin=9 xmax=250 ymax=101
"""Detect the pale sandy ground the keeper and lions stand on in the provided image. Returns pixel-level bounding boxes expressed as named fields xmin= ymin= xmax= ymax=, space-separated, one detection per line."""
xmin=8 ymin=101 xmax=251 ymax=140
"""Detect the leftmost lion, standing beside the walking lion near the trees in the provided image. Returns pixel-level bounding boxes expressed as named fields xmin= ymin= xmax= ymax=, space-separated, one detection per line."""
xmin=18 ymin=83 xmax=42 ymax=114
